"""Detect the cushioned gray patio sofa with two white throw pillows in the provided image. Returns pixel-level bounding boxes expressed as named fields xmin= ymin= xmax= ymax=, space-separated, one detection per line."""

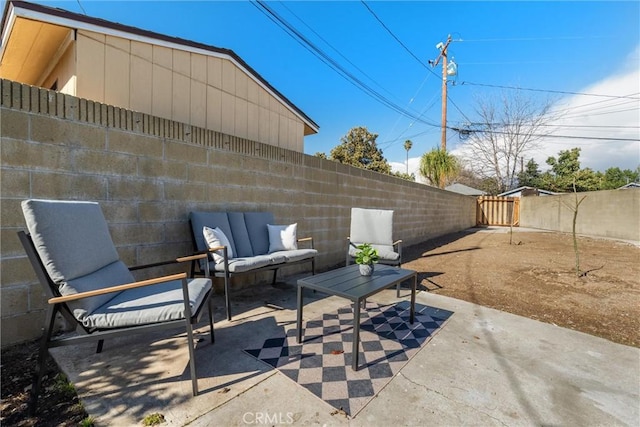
xmin=189 ymin=211 xmax=318 ymax=320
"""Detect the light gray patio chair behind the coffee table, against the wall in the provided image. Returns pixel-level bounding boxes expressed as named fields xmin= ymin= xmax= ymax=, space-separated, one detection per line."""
xmin=346 ymin=208 xmax=402 ymax=296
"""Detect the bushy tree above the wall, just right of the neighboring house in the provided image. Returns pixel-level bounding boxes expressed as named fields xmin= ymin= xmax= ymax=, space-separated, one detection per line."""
xmin=329 ymin=126 xmax=391 ymax=174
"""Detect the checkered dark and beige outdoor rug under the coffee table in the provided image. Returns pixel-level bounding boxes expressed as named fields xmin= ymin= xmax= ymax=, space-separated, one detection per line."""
xmin=245 ymin=301 xmax=453 ymax=417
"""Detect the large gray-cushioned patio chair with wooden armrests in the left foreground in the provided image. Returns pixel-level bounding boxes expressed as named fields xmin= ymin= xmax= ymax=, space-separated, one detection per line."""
xmin=18 ymin=200 xmax=214 ymax=413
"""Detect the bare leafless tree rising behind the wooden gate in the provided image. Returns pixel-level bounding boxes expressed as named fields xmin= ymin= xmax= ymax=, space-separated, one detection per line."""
xmin=464 ymin=92 xmax=556 ymax=196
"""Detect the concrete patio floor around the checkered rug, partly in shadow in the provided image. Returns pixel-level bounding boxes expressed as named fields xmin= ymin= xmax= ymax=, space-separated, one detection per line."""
xmin=52 ymin=277 xmax=640 ymax=426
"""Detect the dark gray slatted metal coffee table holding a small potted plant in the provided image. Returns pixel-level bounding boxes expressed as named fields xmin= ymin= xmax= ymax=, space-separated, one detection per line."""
xmin=297 ymin=264 xmax=418 ymax=371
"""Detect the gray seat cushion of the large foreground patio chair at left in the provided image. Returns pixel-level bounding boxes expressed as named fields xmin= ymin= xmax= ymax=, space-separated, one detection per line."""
xmin=82 ymin=278 xmax=211 ymax=329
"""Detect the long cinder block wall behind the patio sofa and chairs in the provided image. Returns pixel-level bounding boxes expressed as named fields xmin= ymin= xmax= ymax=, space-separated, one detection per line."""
xmin=0 ymin=80 xmax=475 ymax=346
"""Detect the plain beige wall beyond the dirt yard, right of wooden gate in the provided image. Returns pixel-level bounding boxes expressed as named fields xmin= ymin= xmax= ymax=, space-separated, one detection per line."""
xmin=520 ymin=189 xmax=640 ymax=241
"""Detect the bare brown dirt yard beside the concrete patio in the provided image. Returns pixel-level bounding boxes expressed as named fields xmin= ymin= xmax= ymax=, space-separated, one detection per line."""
xmin=403 ymin=228 xmax=640 ymax=347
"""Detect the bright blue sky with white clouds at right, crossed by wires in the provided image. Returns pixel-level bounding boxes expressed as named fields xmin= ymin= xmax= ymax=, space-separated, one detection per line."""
xmin=25 ymin=0 xmax=640 ymax=176
